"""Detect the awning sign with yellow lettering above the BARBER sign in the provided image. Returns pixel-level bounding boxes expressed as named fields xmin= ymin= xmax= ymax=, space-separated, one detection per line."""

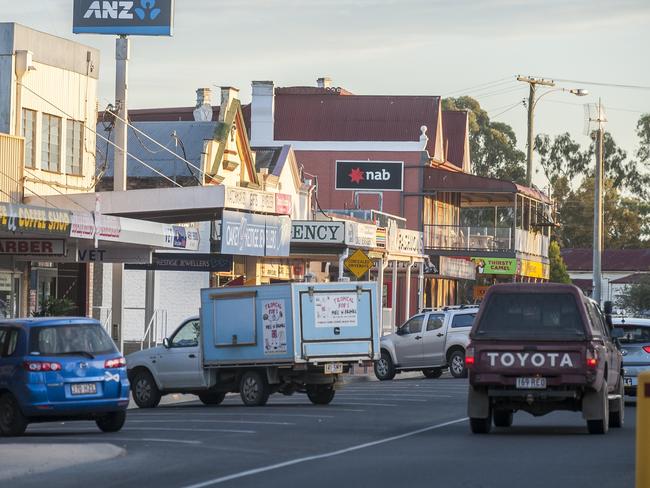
xmin=0 ymin=203 xmax=72 ymax=237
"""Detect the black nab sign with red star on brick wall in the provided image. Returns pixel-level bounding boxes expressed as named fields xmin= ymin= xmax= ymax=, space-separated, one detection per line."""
xmin=336 ymin=161 xmax=404 ymax=191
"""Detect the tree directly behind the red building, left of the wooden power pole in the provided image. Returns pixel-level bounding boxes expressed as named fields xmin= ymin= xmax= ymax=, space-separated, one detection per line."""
xmin=442 ymin=96 xmax=526 ymax=183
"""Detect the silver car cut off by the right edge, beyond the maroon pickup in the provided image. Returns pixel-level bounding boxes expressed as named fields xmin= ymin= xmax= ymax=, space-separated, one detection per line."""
xmin=612 ymin=317 xmax=650 ymax=396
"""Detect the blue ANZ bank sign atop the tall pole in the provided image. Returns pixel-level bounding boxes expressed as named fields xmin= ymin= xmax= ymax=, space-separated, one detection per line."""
xmin=72 ymin=0 xmax=174 ymax=36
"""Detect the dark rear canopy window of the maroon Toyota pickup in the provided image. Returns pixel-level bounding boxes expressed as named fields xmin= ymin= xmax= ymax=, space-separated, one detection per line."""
xmin=474 ymin=293 xmax=585 ymax=340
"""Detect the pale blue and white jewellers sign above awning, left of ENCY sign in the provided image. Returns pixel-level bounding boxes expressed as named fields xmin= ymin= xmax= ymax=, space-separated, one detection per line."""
xmin=220 ymin=210 xmax=291 ymax=257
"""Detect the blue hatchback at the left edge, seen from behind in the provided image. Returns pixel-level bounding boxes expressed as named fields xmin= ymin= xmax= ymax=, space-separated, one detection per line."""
xmin=0 ymin=317 xmax=129 ymax=436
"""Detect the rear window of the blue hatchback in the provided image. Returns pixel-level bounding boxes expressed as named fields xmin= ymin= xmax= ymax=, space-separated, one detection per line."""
xmin=29 ymin=323 xmax=117 ymax=357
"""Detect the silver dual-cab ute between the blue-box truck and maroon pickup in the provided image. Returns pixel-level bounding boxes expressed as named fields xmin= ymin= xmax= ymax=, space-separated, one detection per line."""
xmin=375 ymin=306 xmax=478 ymax=381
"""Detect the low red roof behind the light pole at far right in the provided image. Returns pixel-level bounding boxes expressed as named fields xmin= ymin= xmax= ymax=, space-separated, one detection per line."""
xmin=562 ymin=248 xmax=650 ymax=271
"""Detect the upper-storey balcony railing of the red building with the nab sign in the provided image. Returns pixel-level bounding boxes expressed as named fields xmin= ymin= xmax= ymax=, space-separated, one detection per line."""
xmin=424 ymin=225 xmax=549 ymax=256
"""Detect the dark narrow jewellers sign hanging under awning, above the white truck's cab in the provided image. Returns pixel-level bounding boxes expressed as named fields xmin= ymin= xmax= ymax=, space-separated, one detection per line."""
xmin=124 ymin=252 xmax=233 ymax=273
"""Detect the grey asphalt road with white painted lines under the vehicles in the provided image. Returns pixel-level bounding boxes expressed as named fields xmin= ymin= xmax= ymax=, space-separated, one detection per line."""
xmin=0 ymin=377 xmax=636 ymax=488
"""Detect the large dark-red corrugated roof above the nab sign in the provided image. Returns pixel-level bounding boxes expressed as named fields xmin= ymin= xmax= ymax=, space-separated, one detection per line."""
xmin=274 ymin=87 xmax=440 ymax=154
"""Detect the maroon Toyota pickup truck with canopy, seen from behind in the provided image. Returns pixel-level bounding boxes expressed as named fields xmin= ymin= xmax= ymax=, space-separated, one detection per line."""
xmin=465 ymin=283 xmax=624 ymax=434
